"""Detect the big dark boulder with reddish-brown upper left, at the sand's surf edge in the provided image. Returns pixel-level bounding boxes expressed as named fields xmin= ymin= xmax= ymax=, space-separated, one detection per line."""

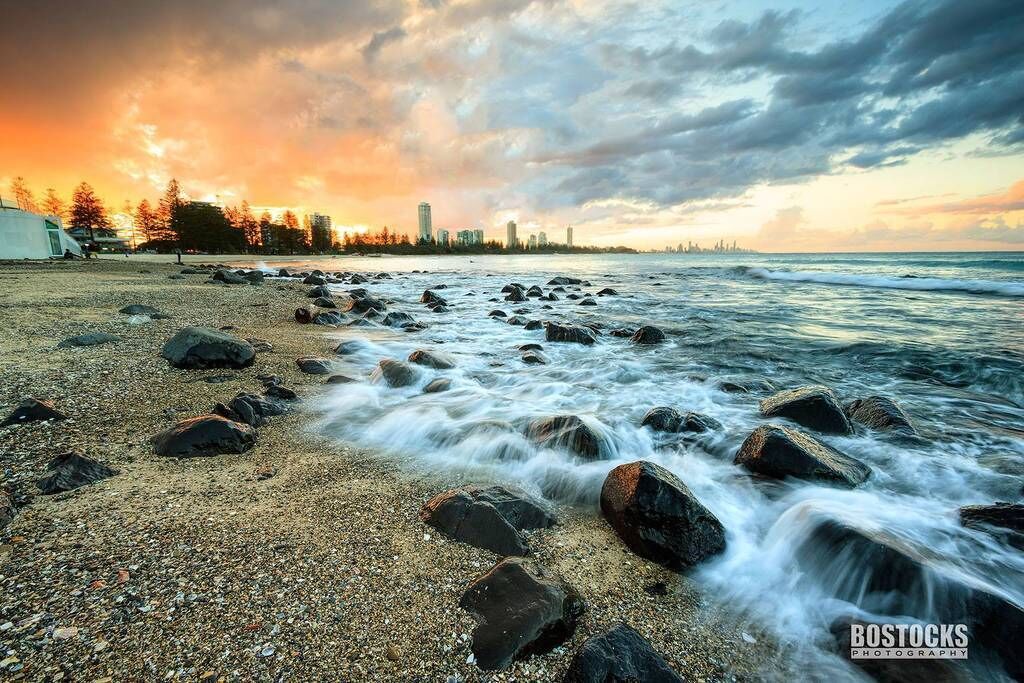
xmin=601 ymin=460 xmax=725 ymax=569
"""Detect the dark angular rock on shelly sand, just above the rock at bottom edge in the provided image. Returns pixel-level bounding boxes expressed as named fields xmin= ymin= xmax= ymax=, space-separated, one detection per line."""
xmin=459 ymin=557 xmax=585 ymax=671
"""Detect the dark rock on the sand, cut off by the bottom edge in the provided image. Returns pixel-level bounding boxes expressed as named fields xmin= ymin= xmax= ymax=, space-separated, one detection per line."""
xmin=562 ymin=624 xmax=683 ymax=683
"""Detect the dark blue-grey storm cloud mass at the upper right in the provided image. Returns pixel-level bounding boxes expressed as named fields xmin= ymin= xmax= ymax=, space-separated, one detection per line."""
xmin=539 ymin=0 xmax=1024 ymax=208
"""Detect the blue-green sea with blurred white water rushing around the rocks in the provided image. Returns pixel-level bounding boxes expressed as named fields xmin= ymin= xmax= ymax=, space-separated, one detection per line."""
xmin=260 ymin=253 xmax=1024 ymax=672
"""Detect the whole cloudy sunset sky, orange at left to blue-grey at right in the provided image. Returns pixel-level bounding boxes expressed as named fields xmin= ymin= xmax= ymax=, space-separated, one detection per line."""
xmin=0 ymin=0 xmax=1024 ymax=251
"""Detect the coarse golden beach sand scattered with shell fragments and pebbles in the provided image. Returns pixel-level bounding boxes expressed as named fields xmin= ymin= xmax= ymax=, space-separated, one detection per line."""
xmin=0 ymin=257 xmax=786 ymax=681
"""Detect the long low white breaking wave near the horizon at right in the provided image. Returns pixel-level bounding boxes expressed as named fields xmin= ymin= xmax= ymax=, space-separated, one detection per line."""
xmin=742 ymin=267 xmax=1024 ymax=297
